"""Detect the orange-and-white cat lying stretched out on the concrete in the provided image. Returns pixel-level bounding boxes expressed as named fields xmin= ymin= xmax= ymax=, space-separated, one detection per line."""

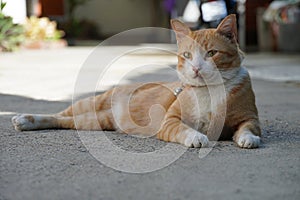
xmin=12 ymin=15 xmax=261 ymax=148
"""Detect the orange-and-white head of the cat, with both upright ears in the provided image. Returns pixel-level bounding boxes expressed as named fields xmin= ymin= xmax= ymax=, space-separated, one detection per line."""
xmin=171 ymin=15 xmax=243 ymax=86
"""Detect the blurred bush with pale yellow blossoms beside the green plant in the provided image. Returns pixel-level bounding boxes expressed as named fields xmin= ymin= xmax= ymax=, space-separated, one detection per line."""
xmin=24 ymin=16 xmax=64 ymax=41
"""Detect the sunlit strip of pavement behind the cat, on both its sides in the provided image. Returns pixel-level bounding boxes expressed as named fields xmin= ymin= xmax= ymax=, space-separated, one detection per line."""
xmin=0 ymin=45 xmax=300 ymax=100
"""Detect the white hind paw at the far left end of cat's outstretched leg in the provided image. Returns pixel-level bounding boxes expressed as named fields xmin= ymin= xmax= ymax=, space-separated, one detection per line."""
xmin=11 ymin=115 xmax=35 ymax=131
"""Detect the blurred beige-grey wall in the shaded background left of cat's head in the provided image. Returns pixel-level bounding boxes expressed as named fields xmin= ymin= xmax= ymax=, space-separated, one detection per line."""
xmin=75 ymin=0 xmax=152 ymax=35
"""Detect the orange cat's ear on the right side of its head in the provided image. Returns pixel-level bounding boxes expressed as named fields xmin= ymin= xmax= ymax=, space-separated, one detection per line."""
xmin=217 ymin=14 xmax=237 ymax=42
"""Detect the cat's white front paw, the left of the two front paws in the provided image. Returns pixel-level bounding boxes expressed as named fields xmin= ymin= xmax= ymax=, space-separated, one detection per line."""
xmin=184 ymin=129 xmax=209 ymax=147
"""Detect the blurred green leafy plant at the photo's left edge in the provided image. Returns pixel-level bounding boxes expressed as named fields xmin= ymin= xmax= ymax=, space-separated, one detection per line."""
xmin=0 ymin=0 xmax=24 ymax=51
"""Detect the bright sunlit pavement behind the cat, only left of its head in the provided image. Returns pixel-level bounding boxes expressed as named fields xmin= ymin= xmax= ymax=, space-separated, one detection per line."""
xmin=0 ymin=46 xmax=176 ymax=100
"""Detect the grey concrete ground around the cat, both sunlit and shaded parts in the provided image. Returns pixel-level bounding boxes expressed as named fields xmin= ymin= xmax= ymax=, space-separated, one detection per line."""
xmin=0 ymin=47 xmax=300 ymax=200
